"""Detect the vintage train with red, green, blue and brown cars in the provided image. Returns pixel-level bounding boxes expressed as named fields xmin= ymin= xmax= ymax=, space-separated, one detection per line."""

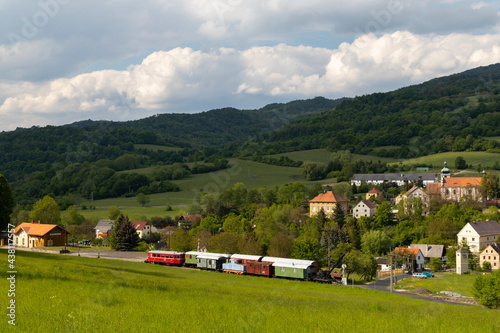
xmin=146 ymin=250 xmax=334 ymax=283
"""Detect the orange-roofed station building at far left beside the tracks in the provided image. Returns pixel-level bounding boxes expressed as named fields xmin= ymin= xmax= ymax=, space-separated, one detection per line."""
xmin=13 ymin=222 xmax=68 ymax=247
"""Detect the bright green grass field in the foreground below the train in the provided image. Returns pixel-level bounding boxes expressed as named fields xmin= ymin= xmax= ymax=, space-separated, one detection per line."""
xmin=0 ymin=250 xmax=500 ymax=332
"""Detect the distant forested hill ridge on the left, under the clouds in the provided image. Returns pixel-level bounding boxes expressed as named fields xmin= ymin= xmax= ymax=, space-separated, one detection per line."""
xmin=0 ymin=97 xmax=342 ymax=201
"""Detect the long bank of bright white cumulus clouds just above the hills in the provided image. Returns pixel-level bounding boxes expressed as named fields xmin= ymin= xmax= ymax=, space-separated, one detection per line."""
xmin=0 ymin=31 xmax=500 ymax=129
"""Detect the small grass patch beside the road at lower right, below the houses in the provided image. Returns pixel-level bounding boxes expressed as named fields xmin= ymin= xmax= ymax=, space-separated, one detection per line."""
xmin=396 ymin=272 xmax=477 ymax=297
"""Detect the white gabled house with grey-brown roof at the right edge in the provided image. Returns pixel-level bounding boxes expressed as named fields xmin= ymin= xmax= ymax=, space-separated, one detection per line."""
xmin=457 ymin=221 xmax=500 ymax=253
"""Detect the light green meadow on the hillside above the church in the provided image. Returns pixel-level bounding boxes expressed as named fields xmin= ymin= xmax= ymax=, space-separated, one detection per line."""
xmin=394 ymin=151 xmax=500 ymax=169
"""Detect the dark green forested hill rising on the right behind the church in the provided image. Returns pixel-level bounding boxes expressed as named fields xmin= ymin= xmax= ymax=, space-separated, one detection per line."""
xmin=259 ymin=64 xmax=500 ymax=158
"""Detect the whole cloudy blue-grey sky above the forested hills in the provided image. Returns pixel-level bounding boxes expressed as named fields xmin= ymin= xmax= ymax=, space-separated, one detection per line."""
xmin=0 ymin=0 xmax=500 ymax=131
